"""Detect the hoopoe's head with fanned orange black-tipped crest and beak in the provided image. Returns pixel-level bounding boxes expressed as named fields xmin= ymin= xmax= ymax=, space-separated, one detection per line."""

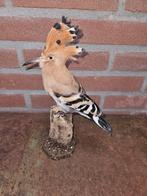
xmin=23 ymin=16 xmax=82 ymax=69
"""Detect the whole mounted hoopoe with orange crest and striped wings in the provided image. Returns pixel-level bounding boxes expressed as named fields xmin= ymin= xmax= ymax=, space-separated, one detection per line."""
xmin=23 ymin=16 xmax=112 ymax=133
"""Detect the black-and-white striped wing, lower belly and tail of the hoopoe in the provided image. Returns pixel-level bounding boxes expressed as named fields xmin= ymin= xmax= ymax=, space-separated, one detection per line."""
xmin=55 ymin=86 xmax=112 ymax=133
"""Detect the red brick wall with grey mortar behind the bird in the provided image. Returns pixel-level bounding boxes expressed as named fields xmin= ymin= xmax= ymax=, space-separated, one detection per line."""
xmin=0 ymin=0 xmax=147 ymax=114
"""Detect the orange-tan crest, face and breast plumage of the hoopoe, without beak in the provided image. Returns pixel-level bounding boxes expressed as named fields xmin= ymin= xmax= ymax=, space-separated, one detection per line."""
xmin=40 ymin=17 xmax=82 ymax=95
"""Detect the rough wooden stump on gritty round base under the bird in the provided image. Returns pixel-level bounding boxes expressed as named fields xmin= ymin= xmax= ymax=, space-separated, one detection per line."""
xmin=43 ymin=106 xmax=75 ymax=160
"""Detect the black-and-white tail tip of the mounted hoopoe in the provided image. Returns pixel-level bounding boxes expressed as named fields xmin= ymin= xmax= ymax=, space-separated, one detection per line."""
xmin=93 ymin=116 xmax=112 ymax=133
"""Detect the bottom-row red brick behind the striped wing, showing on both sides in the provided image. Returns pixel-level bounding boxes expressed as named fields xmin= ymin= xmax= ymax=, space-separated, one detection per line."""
xmin=31 ymin=95 xmax=100 ymax=108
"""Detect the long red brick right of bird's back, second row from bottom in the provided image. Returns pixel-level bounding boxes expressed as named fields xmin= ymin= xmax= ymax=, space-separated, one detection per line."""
xmin=79 ymin=76 xmax=143 ymax=91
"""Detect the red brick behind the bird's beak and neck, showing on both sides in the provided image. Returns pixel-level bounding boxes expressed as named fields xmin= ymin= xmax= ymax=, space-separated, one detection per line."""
xmin=24 ymin=49 xmax=109 ymax=70
